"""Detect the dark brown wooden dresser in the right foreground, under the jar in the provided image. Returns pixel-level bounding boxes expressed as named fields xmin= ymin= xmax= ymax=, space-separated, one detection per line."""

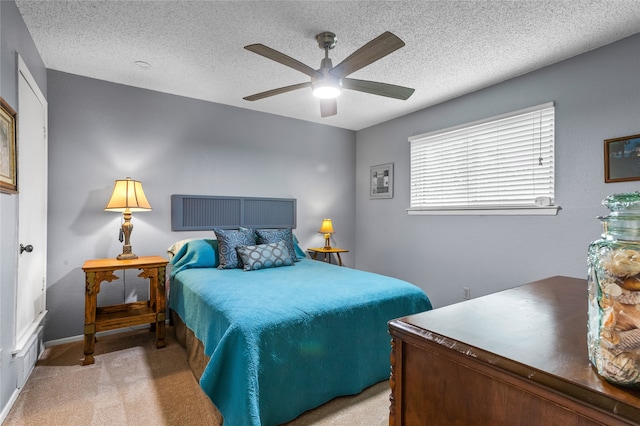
xmin=389 ymin=277 xmax=640 ymax=426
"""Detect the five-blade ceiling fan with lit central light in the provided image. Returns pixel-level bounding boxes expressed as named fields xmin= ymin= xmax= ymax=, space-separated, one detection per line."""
xmin=243 ymin=31 xmax=414 ymax=117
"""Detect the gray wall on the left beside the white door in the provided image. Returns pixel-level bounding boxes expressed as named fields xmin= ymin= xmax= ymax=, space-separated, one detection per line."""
xmin=0 ymin=1 xmax=47 ymax=411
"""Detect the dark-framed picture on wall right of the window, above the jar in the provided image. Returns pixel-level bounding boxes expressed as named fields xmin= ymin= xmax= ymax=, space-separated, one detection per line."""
xmin=604 ymin=134 xmax=640 ymax=183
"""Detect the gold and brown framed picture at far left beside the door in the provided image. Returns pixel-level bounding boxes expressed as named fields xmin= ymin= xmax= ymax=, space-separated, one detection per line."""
xmin=0 ymin=97 xmax=18 ymax=194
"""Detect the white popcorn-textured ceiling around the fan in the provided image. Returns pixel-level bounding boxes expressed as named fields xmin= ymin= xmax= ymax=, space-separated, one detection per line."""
xmin=16 ymin=0 xmax=640 ymax=130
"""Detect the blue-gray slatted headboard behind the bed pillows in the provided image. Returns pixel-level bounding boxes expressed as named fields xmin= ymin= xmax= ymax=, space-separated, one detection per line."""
xmin=171 ymin=194 xmax=296 ymax=231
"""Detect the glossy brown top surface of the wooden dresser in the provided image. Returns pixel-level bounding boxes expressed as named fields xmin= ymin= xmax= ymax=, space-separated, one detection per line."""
xmin=390 ymin=276 xmax=640 ymax=417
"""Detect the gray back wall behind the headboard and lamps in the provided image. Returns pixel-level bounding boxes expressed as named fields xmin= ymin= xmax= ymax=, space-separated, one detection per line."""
xmin=44 ymin=71 xmax=355 ymax=341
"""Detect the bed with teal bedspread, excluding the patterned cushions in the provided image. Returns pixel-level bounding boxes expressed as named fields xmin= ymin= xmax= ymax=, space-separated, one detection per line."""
xmin=169 ymin=238 xmax=431 ymax=426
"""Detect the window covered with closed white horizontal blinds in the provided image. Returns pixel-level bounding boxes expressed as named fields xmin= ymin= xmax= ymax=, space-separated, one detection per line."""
xmin=408 ymin=103 xmax=558 ymax=214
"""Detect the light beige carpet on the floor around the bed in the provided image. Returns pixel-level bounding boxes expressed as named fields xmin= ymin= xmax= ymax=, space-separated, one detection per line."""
xmin=3 ymin=330 xmax=389 ymax=426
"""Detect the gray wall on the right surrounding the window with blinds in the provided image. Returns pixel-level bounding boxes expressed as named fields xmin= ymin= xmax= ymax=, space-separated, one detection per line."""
xmin=356 ymin=34 xmax=640 ymax=309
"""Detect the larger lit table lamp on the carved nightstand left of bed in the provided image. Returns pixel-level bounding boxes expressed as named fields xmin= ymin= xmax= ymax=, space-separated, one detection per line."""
xmin=104 ymin=177 xmax=151 ymax=260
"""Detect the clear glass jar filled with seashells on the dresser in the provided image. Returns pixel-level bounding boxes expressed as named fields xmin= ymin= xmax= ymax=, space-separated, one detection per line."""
xmin=587 ymin=192 xmax=640 ymax=387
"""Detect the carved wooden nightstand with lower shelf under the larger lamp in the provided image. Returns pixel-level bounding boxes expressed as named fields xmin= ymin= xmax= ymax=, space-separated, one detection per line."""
xmin=82 ymin=256 xmax=169 ymax=365
